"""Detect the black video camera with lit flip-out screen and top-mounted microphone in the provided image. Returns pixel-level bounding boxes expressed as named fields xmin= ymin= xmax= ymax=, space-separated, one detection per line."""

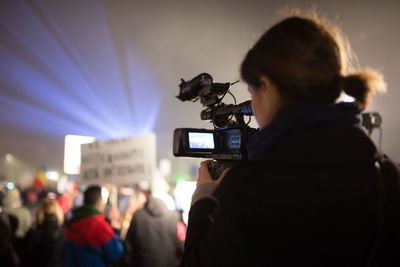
xmin=173 ymin=73 xmax=256 ymax=178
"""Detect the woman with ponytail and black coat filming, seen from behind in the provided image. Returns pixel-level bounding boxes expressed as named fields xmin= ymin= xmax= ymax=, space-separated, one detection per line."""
xmin=182 ymin=9 xmax=400 ymax=267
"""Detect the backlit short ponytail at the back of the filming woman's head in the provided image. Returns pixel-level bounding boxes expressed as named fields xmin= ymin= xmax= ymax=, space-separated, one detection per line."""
xmin=340 ymin=69 xmax=386 ymax=111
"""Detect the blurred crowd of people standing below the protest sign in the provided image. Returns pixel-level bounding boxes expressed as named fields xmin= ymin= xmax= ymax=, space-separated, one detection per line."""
xmin=0 ymin=185 xmax=186 ymax=267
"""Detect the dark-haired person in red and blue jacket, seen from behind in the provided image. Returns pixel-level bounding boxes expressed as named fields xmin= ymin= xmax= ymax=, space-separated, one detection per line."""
xmin=64 ymin=186 xmax=123 ymax=267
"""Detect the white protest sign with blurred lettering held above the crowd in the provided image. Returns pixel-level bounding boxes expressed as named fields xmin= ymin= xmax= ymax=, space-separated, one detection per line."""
xmin=78 ymin=134 xmax=156 ymax=185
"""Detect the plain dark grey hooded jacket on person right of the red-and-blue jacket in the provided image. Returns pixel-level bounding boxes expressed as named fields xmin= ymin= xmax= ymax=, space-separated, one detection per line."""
xmin=125 ymin=197 xmax=183 ymax=267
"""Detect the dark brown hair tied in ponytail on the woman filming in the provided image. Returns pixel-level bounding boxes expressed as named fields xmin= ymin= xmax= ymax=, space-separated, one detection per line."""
xmin=241 ymin=11 xmax=385 ymax=110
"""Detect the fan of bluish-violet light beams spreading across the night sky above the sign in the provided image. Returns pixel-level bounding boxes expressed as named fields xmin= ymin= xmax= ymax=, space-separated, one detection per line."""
xmin=0 ymin=0 xmax=160 ymax=139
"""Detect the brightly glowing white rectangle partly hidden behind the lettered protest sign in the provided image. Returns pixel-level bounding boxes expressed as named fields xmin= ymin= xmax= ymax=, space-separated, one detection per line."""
xmin=64 ymin=135 xmax=96 ymax=175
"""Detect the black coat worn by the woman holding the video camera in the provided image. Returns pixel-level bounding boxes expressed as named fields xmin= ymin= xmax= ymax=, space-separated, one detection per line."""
xmin=182 ymin=125 xmax=398 ymax=267
